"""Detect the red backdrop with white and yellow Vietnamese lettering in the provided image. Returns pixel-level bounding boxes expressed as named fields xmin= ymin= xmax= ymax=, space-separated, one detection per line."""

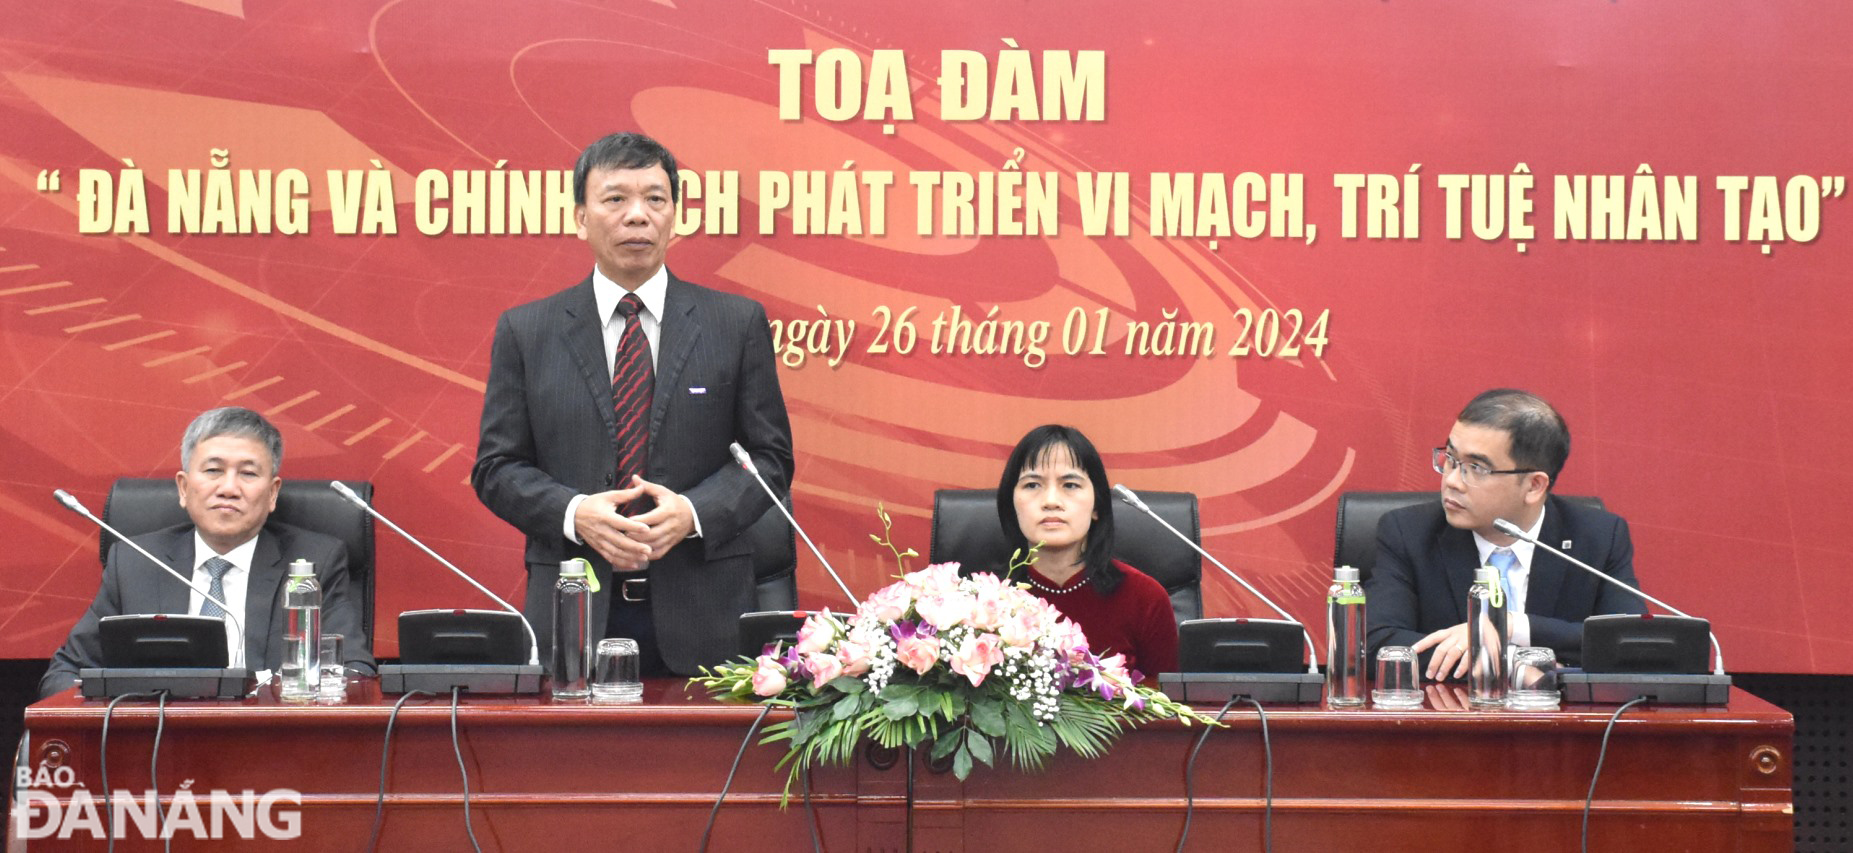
xmin=0 ymin=0 xmax=1853 ymax=673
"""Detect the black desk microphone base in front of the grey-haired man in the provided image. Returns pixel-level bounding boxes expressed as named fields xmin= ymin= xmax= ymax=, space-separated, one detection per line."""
xmin=78 ymin=614 xmax=258 ymax=699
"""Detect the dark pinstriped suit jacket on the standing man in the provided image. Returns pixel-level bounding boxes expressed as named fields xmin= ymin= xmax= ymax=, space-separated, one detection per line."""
xmin=471 ymin=274 xmax=791 ymax=675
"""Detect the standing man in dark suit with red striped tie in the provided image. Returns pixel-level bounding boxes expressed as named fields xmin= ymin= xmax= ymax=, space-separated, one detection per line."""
xmin=471 ymin=134 xmax=791 ymax=675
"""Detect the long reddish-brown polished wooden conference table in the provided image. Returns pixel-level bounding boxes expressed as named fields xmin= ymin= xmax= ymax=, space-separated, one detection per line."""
xmin=13 ymin=681 xmax=1794 ymax=851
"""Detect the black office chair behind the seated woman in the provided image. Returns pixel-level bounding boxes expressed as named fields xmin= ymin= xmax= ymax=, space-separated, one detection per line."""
xmin=927 ymin=490 xmax=1203 ymax=621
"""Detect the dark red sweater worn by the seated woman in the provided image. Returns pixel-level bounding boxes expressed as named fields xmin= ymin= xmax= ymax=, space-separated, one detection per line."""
xmin=1028 ymin=560 xmax=1177 ymax=686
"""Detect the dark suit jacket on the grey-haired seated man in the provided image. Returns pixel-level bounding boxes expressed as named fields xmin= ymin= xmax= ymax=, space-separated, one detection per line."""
xmin=39 ymin=521 xmax=372 ymax=697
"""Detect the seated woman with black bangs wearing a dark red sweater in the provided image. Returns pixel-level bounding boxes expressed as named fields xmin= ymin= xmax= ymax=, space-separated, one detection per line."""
xmin=997 ymin=425 xmax=1177 ymax=677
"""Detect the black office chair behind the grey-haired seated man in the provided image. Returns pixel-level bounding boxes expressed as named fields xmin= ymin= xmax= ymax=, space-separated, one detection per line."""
xmin=96 ymin=477 xmax=376 ymax=638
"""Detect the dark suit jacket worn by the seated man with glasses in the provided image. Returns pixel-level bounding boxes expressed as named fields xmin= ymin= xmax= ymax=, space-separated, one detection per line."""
xmin=1364 ymin=495 xmax=1647 ymax=666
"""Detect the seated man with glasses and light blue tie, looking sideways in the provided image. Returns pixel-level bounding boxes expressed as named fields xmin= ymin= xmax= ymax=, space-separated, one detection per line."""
xmin=1366 ymin=389 xmax=1645 ymax=679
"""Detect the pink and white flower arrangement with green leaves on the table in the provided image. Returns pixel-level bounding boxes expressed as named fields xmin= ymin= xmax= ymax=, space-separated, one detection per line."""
xmin=689 ymin=512 xmax=1214 ymax=794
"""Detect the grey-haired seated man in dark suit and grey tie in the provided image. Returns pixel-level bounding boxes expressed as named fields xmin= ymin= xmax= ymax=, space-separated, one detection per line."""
xmin=39 ymin=408 xmax=372 ymax=695
